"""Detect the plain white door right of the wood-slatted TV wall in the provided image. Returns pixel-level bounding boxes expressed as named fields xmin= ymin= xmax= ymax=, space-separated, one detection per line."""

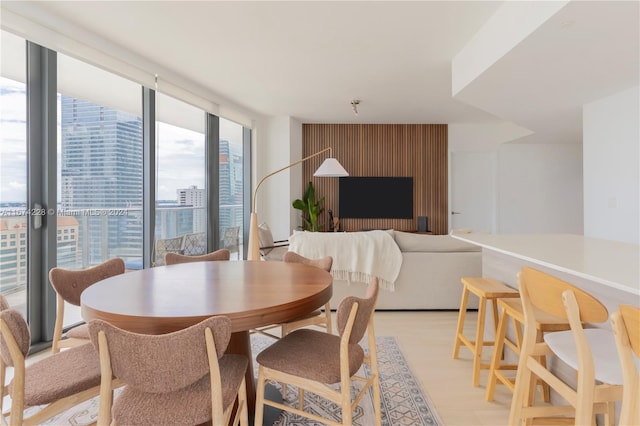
xmin=449 ymin=151 xmax=497 ymax=233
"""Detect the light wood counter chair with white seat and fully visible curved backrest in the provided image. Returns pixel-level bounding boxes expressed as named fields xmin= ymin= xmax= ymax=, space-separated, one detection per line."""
xmin=509 ymin=267 xmax=622 ymax=425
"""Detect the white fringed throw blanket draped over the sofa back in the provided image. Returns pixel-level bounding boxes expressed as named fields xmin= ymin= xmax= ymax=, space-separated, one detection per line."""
xmin=289 ymin=231 xmax=402 ymax=291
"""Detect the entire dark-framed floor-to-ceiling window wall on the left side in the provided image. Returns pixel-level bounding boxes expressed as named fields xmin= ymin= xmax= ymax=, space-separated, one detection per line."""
xmin=0 ymin=27 xmax=250 ymax=346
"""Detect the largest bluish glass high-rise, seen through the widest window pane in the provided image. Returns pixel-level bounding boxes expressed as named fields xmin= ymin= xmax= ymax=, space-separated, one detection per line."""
xmin=60 ymin=95 xmax=143 ymax=267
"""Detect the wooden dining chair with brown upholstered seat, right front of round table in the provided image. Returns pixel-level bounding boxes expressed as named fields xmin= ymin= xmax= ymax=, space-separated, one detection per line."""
xmin=255 ymin=278 xmax=381 ymax=425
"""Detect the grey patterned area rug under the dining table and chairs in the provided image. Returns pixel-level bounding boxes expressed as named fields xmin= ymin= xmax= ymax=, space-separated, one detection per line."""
xmin=30 ymin=335 xmax=443 ymax=426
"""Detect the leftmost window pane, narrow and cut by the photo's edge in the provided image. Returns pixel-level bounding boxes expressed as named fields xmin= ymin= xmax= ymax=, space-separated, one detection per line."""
xmin=0 ymin=31 xmax=30 ymax=316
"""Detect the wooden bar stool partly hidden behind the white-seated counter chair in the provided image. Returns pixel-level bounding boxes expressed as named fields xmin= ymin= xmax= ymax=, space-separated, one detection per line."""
xmin=485 ymin=299 xmax=571 ymax=402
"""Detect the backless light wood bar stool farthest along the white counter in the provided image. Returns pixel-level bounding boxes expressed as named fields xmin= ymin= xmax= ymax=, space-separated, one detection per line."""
xmin=453 ymin=277 xmax=520 ymax=386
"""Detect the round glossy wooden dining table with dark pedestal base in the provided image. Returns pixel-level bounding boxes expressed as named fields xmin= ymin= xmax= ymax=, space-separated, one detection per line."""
xmin=81 ymin=261 xmax=333 ymax=411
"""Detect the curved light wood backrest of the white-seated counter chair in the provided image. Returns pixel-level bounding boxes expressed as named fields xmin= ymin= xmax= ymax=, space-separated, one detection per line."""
xmin=518 ymin=266 xmax=609 ymax=323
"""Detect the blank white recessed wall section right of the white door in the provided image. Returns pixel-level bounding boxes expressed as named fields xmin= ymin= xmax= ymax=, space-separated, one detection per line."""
xmin=497 ymin=143 xmax=583 ymax=234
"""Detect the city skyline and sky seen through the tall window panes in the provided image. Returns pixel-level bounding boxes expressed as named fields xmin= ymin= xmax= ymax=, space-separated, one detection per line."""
xmin=0 ymin=72 xmax=244 ymax=292
